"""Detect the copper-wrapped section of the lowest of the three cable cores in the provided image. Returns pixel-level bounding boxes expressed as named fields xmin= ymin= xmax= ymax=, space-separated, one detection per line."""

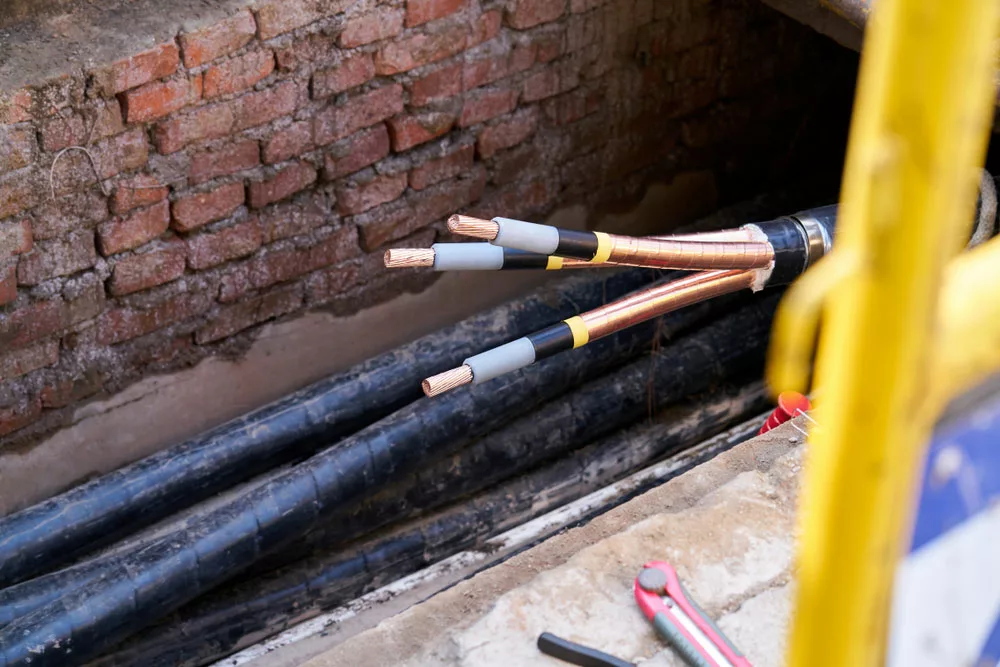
xmin=580 ymin=270 xmax=754 ymax=340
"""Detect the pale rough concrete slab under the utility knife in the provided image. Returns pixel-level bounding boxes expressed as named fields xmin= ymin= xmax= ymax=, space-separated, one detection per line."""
xmin=305 ymin=425 xmax=803 ymax=667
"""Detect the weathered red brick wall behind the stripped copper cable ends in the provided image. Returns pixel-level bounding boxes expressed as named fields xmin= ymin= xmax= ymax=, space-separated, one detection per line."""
xmin=0 ymin=0 xmax=849 ymax=443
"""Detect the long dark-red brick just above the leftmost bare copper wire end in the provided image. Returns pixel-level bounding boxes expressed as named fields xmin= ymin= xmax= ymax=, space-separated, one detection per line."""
xmin=355 ymin=167 xmax=486 ymax=252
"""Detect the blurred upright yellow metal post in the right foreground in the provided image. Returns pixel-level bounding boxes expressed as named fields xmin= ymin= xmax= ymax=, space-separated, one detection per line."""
xmin=770 ymin=0 xmax=1000 ymax=667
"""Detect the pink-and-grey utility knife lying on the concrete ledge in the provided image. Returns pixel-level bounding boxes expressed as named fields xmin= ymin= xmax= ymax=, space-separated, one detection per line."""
xmin=634 ymin=561 xmax=751 ymax=667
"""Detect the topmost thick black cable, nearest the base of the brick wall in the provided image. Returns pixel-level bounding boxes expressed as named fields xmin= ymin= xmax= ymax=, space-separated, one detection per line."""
xmin=0 ymin=271 xmax=656 ymax=588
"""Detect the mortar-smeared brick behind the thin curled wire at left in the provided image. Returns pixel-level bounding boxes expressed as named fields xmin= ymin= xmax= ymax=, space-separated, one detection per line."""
xmin=46 ymin=127 xmax=149 ymax=194
